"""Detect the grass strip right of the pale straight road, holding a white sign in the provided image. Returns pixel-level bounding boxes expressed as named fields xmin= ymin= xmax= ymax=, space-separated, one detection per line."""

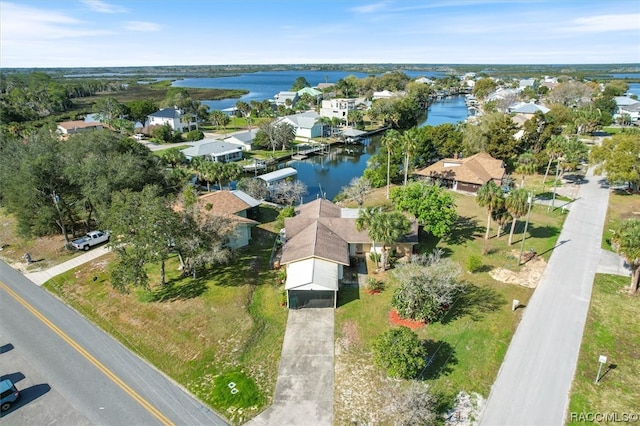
xmin=567 ymin=274 xmax=640 ymax=425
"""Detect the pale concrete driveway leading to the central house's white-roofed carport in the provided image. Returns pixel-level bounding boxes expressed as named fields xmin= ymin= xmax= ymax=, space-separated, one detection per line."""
xmin=247 ymin=308 xmax=335 ymax=426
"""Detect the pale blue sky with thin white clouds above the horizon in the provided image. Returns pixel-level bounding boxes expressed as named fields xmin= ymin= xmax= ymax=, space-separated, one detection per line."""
xmin=0 ymin=0 xmax=640 ymax=68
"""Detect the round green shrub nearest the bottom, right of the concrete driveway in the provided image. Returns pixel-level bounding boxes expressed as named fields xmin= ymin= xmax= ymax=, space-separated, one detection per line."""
xmin=371 ymin=327 xmax=427 ymax=379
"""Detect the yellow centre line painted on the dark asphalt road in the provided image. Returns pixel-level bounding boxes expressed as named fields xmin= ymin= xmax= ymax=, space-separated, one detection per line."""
xmin=0 ymin=281 xmax=173 ymax=426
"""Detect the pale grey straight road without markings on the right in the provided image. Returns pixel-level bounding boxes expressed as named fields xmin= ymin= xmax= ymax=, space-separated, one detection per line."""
xmin=480 ymin=173 xmax=609 ymax=426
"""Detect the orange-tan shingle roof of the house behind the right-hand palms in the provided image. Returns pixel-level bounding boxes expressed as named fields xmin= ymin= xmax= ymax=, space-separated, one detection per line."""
xmin=415 ymin=152 xmax=505 ymax=185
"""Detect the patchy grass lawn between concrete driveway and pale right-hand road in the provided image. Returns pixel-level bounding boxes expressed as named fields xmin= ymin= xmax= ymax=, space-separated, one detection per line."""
xmin=334 ymin=188 xmax=564 ymax=421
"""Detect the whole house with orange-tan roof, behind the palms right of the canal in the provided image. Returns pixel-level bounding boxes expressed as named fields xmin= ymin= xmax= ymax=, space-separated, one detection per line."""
xmin=415 ymin=152 xmax=505 ymax=193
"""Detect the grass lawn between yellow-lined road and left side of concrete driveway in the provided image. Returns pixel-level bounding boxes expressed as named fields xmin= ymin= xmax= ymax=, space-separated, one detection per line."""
xmin=45 ymin=208 xmax=287 ymax=424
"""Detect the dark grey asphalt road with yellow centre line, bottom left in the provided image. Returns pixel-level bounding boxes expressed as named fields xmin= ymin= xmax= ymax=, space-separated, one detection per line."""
xmin=0 ymin=261 xmax=227 ymax=425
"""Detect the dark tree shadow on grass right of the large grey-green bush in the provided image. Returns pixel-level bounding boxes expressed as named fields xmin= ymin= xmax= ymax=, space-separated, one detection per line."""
xmin=440 ymin=284 xmax=507 ymax=324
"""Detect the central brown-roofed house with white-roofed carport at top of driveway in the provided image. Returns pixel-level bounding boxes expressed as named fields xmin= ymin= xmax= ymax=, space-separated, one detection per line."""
xmin=280 ymin=198 xmax=418 ymax=309
